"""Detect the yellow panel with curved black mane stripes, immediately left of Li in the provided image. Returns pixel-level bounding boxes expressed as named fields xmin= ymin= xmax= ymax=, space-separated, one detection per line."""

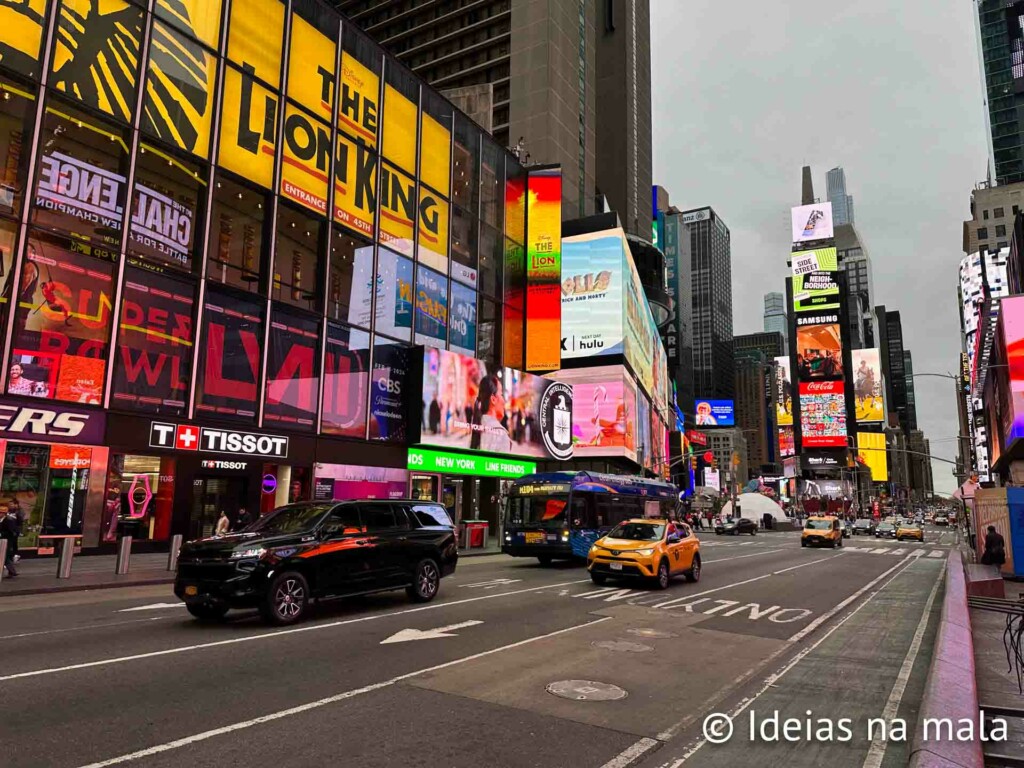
xmin=141 ymin=21 xmax=220 ymax=159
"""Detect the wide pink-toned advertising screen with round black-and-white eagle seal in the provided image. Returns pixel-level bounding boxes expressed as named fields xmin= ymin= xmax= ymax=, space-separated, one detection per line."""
xmin=420 ymin=349 xmax=572 ymax=459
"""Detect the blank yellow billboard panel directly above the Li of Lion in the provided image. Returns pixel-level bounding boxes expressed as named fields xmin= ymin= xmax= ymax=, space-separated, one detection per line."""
xmin=227 ymin=0 xmax=285 ymax=88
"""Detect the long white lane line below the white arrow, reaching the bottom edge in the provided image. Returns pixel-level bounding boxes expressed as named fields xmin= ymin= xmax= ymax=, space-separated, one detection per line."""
xmin=82 ymin=616 xmax=613 ymax=768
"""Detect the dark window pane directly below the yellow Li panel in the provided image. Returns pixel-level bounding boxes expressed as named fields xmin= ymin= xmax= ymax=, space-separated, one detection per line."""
xmin=206 ymin=174 xmax=267 ymax=293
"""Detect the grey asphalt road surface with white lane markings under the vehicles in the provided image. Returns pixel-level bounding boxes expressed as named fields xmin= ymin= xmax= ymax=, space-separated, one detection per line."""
xmin=0 ymin=528 xmax=955 ymax=768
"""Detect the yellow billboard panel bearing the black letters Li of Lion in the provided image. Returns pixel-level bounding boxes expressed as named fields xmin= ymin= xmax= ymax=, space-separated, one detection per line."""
xmin=217 ymin=67 xmax=278 ymax=187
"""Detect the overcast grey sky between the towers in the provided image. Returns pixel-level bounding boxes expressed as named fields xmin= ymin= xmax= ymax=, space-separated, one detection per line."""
xmin=651 ymin=0 xmax=987 ymax=493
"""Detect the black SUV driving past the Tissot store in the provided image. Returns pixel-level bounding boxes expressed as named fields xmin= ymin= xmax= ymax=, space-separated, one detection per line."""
xmin=174 ymin=501 xmax=459 ymax=624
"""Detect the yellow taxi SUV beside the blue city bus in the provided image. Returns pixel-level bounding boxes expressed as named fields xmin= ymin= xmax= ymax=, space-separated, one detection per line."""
xmin=587 ymin=519 xmax=700 ymax=590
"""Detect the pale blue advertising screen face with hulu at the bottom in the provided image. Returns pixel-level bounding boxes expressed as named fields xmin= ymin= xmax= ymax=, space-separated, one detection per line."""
xmin=561 ymin=229 xmax=628 ymax=359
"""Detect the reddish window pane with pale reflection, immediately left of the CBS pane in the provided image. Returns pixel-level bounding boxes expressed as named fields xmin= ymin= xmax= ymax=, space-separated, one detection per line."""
xmin=321 ymin=323 xmax=370 ymax=437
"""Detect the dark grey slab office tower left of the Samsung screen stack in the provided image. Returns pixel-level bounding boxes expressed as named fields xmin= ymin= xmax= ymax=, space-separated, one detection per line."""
xmin=683 ymin=207 xmax=735 ymax=398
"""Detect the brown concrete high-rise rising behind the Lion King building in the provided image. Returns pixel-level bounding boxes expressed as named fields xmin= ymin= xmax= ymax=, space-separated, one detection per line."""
xmin=332 ymin=0 xmax=651 ymax=238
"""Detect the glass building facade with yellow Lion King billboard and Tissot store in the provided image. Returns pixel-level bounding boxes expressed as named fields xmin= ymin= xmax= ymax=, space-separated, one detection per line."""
xmin=0 ymin=0 xmax=526 ymax=550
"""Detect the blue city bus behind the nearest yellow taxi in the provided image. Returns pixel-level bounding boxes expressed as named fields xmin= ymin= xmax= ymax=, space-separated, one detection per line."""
xmin=502 ymin=472 xmax=679 ymax=565
